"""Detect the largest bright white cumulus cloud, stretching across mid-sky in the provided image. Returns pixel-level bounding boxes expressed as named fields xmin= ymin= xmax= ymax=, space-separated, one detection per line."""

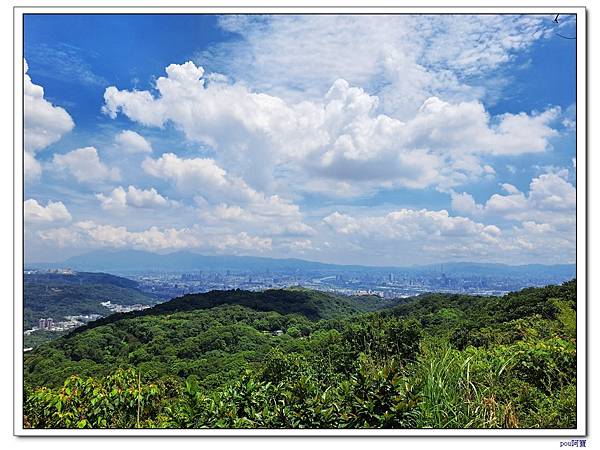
xmin=103 ymin=62 xmax=560 ymax=193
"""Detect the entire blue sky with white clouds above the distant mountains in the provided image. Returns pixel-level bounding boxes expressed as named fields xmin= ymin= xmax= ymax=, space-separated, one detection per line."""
xmin=23 ymin=14 xmax=576 ymax=266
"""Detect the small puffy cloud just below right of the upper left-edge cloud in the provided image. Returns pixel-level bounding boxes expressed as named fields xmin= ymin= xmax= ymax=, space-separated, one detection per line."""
xmin=52 ymin=147 xmax=120 ymax=183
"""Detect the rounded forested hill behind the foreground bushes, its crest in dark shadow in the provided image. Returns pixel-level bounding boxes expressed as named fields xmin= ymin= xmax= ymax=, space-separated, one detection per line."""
xmin=26 ymin=289 xmax=404 ymax=386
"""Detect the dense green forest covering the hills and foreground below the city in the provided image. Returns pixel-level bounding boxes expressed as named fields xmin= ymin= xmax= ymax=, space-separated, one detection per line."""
xmin=23 ymin=280 xmax=576 ymax=428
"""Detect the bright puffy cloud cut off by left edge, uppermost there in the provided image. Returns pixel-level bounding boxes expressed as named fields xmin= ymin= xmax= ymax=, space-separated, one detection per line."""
xmin=23 ymin=61 xmax=75 ymax=180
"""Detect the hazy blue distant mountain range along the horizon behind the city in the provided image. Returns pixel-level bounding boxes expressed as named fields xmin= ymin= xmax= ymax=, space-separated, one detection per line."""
xmin=26 ymin=250 xmax=576 ymax=279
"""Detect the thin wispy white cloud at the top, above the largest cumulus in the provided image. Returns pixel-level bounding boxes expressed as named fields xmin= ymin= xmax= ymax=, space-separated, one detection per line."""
xmin=206 ymin=15 xmax=556 ymax=113
